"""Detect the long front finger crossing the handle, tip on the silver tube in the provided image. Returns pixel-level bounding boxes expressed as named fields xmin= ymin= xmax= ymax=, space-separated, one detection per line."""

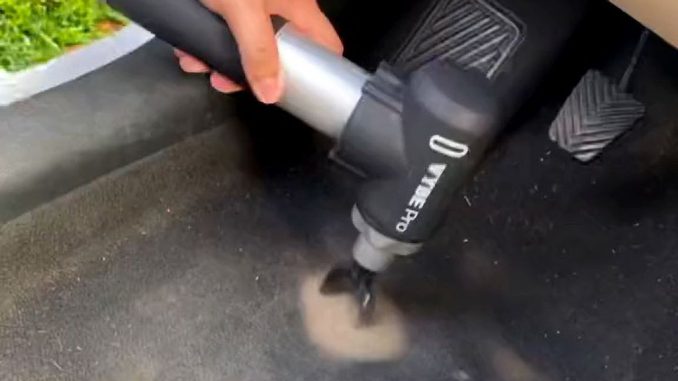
xmin=205 ymin=0 xmax=283 ymax=104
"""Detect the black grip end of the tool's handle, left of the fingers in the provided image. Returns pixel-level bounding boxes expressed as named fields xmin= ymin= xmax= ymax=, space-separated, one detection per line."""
xmin=108 ymin=0 xmax=282 ymax=85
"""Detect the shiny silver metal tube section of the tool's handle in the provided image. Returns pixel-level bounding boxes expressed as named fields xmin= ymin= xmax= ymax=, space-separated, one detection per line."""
xmin=277 ymin=24 xmax=369 ymax=139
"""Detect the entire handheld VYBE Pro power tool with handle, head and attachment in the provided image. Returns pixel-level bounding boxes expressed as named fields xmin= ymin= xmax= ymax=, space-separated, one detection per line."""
xmin=108 ymin=0 xmax=501 ymax=322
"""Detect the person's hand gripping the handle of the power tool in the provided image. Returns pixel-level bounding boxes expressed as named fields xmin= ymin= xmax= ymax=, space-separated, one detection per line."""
xmin=175 ymin=0 xmax=343 ymax=104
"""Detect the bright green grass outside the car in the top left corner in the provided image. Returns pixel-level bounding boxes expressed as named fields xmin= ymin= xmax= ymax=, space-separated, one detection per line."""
xmin=0 ymin=0 xmax=126 ymax=72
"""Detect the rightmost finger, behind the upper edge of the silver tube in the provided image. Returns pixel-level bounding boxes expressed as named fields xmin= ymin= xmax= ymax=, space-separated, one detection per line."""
xmin=271 ymin=0 xmax=344 ymax=54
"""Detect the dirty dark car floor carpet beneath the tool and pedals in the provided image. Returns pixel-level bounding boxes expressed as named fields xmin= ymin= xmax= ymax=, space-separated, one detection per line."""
xmin=0 ymin=1 xmax=678 ymax=381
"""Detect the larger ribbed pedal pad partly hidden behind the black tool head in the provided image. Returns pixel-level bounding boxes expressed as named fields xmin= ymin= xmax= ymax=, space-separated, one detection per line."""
xmin=393 ymin=0 xmax=525 ymax=79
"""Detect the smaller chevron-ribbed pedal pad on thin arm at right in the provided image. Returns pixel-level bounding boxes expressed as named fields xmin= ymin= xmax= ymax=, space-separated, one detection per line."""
xmin=549 ymin=70 xmax=645 ymax=162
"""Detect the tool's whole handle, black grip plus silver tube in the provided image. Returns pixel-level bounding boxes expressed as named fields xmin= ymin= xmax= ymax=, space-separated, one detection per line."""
xmin=108 ymin=0 xmax=369 ymax=139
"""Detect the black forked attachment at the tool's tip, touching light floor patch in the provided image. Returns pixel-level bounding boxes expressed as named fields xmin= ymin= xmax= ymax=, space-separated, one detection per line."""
xmin=320 ymin=261 xmax=377 ymax=325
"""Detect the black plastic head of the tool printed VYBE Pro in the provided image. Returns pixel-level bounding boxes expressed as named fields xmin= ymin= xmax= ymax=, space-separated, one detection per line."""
xmin=337 ymin=61 xmax=503 ymax=243
